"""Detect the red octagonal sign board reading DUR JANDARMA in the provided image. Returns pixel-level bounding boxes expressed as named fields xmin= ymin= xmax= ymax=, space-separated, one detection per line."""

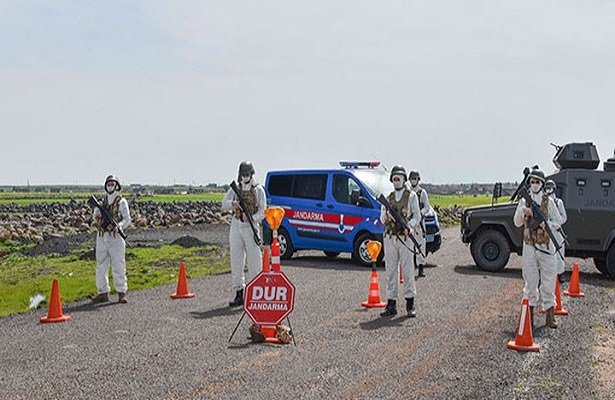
xmin=243 ymin=271 xmax=295 ymax=325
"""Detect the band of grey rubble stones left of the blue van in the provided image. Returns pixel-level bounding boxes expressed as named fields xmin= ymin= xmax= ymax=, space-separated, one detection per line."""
xmin=0 ymin=201 xmax=231 ymax=243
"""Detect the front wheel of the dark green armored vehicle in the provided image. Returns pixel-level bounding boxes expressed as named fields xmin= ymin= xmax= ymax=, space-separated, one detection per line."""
xmin=470 ymin=229 xmax=510 ymax=272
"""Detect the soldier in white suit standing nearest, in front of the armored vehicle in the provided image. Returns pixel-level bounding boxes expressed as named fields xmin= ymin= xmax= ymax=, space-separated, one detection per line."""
xmin=513 ymin=168 xmax=560 ymax=328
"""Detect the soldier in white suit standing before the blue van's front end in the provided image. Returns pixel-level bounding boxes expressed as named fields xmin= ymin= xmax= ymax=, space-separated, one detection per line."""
xmin=380 ymin=165 xmax=421 ymax=318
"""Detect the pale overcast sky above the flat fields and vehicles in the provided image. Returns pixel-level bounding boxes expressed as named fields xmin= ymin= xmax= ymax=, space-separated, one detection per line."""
xmin=0 ymin=0 xmax=615 ymax=185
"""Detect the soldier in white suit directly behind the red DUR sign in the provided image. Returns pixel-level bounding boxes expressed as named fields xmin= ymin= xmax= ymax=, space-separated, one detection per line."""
xmin=222 ymin=161 xmax=267 ymax=307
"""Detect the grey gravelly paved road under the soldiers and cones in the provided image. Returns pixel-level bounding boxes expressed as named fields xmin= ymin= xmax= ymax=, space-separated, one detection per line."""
xmin=0 ymin=228 xmax=615 ymax=399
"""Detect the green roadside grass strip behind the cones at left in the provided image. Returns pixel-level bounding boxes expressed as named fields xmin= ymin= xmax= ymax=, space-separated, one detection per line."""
xmin=0 ymin=244 xmax=230 ymax=316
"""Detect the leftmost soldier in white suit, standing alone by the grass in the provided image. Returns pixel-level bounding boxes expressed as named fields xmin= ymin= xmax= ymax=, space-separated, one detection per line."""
xmin=92 ymin=175 xmax=131 ymax=303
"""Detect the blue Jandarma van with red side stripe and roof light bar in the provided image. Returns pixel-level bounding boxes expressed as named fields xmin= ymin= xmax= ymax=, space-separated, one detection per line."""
xmin=265 ymin=161 xmax=441 ymax=266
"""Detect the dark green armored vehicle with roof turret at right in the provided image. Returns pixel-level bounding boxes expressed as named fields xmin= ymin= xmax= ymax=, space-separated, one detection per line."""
xmin=461 ymin=142 xmax=615 ymax=279
